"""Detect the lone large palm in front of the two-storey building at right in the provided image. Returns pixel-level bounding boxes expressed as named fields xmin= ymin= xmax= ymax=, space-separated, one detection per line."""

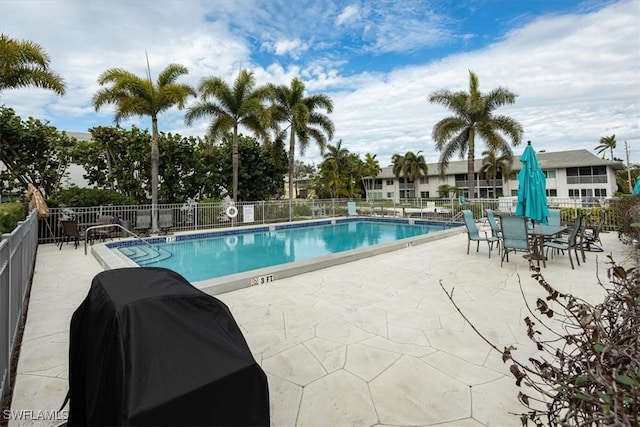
xmin=428 ymin=71 xmax=523 ymax=197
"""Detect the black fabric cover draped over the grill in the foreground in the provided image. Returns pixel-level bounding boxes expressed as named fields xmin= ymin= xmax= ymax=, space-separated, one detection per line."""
xmin=68 ymin=268 xmax=269 ymax=426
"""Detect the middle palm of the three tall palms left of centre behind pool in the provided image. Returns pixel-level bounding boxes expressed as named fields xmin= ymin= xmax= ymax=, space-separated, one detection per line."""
xmin=186 ymin=70 xmax=269 ymax=202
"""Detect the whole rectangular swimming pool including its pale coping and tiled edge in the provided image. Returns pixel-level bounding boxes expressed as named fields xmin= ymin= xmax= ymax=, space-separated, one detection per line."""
xmin=94 ymin=218 xmax=461 ymax=291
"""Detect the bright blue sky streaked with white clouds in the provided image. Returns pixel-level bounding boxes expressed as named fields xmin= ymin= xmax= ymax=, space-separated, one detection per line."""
xmin=0 ymin=0 xmax=640 ymax=166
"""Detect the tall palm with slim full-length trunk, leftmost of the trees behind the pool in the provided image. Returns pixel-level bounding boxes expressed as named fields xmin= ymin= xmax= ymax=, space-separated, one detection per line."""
xmin=93 ymin=64 xmax=196 ymax=231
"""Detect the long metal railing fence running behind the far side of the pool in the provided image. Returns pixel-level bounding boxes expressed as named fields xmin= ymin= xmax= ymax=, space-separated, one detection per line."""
xmin=38 ymin=197 xmax=618 ymax=243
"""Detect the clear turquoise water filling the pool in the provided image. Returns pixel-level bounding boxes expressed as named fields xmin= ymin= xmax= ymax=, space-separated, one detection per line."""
xmin=118 ymin=221 xmax=456 ymax=282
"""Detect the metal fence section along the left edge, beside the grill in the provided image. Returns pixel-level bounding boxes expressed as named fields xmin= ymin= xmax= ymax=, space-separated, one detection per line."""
xmin=0 ymin=210 xmax=38 ymax=399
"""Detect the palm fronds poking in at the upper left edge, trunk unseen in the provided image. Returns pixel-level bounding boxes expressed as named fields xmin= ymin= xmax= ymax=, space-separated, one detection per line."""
xmin=0 ymin=34 xmax=65 ymax=96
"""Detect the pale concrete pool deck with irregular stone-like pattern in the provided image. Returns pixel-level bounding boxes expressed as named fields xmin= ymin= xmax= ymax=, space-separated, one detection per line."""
xmin=9 ymin=227 xmax=633 ymax=427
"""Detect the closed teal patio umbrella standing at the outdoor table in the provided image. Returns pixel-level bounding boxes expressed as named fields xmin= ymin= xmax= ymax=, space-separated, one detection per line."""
xmin=516 ymin=141 xmax=549 ymax=224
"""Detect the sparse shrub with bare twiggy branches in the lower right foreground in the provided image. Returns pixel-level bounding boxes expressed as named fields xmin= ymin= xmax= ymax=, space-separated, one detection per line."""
xmin=440 ymin=257 xmax=640 ymax=426
